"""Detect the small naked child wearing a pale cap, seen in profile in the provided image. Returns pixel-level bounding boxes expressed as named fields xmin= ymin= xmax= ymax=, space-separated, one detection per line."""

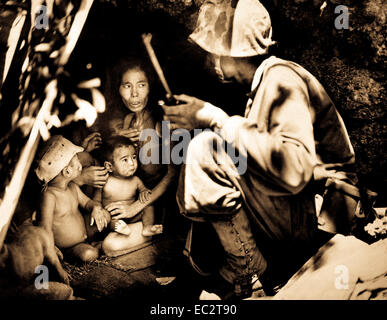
xmin=35 ymin=135 xmax=110 ymax=261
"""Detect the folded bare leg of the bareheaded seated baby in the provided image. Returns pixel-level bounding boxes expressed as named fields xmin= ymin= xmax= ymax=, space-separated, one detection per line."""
xmin=102 ymin=221 xmax=150 ymax=257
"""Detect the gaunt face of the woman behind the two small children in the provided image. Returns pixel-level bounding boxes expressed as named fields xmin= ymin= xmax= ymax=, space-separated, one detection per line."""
xmin=119 ymin=68 xmax=149 ymax=112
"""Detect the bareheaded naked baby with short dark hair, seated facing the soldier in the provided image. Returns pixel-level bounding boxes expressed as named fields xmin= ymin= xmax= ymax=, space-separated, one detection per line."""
xmin=94 ymin=136 xmax=163 ymax=256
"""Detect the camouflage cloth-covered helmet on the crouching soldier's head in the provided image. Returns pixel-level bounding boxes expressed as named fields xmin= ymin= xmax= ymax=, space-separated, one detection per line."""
xmin=189 ymin=0 xmax=274 ymax=57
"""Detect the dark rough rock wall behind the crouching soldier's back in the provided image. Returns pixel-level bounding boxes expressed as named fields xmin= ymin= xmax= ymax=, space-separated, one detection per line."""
xmin=273 ymin=0 xmax=387 ymax=203
